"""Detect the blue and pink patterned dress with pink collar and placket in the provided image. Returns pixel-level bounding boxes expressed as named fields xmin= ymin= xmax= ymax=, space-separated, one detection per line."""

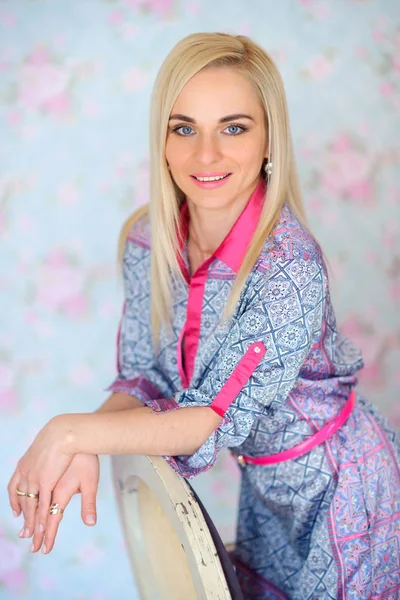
xmin=107 ymin=178 xmax=400 ymax=600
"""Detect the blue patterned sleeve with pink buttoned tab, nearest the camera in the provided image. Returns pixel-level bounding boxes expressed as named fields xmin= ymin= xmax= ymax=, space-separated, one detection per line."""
xmin=156 ymin=258 xmax=327 ymax=478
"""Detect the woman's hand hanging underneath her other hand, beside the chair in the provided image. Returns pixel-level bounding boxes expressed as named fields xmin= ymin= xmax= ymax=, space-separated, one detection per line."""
xmin=31 ymin=454 xmax=100 ymax=554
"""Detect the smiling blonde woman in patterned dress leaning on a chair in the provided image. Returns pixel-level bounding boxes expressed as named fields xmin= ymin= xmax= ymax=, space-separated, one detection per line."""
xmin=9 ymin=33 xmax=400 ymax=600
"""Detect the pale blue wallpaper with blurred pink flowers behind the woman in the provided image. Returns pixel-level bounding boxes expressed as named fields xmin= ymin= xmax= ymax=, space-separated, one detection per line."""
xmin=0 ymin=0 xmax=400 ymax=600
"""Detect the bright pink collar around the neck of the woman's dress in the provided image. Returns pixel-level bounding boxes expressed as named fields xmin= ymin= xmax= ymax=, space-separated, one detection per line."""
xmin=179 ymin=175 xmax=266 ymax=281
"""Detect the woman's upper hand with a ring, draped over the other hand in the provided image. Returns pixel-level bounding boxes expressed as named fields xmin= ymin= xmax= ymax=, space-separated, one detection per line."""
xmin=8 ymin=415 xmax=74 ymax=538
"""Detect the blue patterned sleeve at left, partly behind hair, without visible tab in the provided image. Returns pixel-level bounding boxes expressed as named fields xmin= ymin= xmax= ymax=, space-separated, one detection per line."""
xmin=105 ymin=234 xmax=174 ymax=407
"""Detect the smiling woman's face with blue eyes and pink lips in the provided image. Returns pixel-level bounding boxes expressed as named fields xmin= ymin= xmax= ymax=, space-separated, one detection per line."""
xmin=165 ymin=68 xmax=268 ymax=209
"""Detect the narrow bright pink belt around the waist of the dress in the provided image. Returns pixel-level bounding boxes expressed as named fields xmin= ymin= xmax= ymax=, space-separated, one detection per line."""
xmin=232 ymin=390 xmax=356 ymax=465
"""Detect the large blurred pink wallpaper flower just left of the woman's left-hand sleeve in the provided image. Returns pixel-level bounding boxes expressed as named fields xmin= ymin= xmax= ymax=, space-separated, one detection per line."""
xmin=36 ymin=250 xmax=87 ymax=317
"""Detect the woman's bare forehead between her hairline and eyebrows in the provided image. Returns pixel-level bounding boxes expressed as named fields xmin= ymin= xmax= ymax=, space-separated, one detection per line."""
xmin=171 ymin=67 xmax=262 ymax=120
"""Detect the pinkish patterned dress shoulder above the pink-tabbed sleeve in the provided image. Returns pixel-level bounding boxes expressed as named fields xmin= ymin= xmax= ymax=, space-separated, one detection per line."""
xmin=256 ymin=204 xmax=325 ymax=273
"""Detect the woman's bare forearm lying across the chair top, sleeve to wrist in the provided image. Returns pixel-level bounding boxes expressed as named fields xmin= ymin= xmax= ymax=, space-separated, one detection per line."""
xmin=58 ymin=407 xmax=221 ymax=456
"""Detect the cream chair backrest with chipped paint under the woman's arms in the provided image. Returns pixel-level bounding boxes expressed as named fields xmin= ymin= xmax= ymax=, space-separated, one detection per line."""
xmin=111 ymin=455 xmax=231 ymax=600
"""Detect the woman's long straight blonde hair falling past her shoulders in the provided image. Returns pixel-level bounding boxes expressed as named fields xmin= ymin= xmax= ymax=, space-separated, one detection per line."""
xmin=119 ymin=33 xmax=318 ymax=346
